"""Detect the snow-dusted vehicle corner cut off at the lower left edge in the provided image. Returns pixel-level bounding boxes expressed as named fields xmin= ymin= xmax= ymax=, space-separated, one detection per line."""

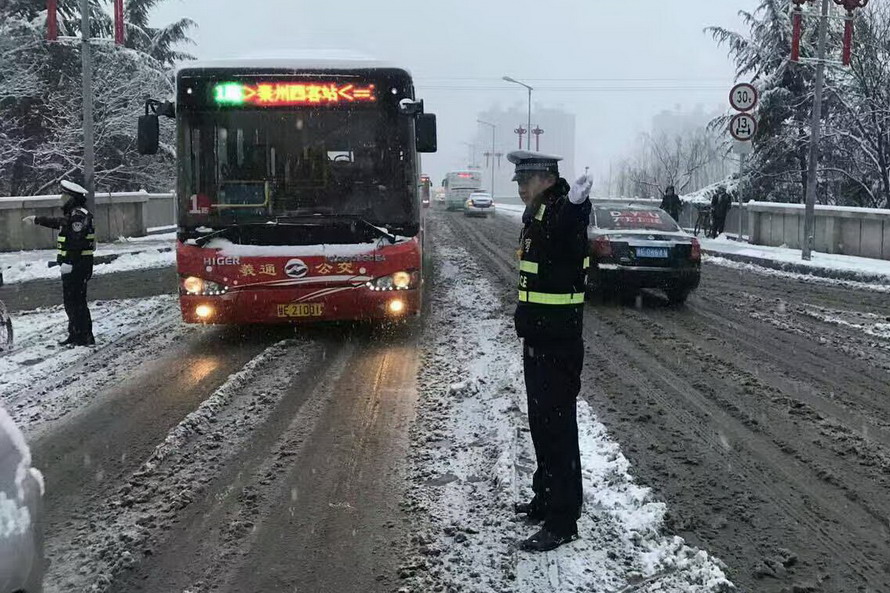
xmin=0 ymin=408 xmax=46 ymax=593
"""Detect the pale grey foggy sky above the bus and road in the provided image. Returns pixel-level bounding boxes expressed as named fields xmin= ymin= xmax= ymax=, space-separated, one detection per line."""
xmin=154 ymin=0 xmax=755 ymax=185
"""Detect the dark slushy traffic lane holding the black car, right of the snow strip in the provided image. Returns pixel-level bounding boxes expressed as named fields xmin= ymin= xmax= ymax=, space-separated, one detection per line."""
xmin=448 ymin=213 xmax=890 ymax=593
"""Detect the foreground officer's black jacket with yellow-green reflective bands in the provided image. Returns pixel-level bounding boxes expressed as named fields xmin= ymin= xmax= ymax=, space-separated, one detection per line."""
xmin=515 ymin=180 xmax=590 ymax=340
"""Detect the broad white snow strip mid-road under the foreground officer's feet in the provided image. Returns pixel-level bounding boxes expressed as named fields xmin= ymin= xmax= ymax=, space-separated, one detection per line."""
xmin=399 ymin=220 xmax=734 ymax=593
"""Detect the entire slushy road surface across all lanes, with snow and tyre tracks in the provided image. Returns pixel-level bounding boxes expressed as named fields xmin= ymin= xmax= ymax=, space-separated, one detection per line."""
xmin=0 ymin=212 xmax=890 ymax=593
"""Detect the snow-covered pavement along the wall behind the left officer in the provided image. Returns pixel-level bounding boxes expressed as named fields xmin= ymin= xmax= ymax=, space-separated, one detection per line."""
xmin=0 ymin=233 xmax=176 ymax=284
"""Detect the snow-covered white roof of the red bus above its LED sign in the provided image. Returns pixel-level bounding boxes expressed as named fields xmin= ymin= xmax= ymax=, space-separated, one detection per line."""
xmin=177 ymin=52 xmax=411 ymax=76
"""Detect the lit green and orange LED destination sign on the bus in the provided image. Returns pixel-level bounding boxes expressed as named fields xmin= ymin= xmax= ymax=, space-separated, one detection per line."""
xmin=213 ymin=82 xmax=377 ymax=107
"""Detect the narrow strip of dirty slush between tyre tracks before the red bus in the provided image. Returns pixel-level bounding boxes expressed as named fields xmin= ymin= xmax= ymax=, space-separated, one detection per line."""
xmin=46 ymin=340 xmax=311 ymax=593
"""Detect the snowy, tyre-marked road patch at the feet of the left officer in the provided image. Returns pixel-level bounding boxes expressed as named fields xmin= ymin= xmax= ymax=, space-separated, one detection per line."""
xmin=0 ymin=296 xmax=182 ymax=438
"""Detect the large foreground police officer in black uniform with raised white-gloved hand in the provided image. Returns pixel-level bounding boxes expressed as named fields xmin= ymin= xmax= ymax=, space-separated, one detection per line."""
xmin=507 ymin=151 xmax=591 ymax=551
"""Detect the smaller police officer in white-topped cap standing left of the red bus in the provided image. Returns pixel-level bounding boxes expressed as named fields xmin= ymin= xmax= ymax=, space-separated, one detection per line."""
xmin=23 ymin=181 xmax=96 ymax=346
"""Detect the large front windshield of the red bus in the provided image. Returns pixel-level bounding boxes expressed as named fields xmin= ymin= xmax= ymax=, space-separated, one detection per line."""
xmin=180 ymin=109 xmax=418 ymax=228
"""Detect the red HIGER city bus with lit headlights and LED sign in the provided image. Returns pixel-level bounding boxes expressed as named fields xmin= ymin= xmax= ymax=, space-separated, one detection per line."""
xmin=139 ymin=60 xmax=436 ymax=324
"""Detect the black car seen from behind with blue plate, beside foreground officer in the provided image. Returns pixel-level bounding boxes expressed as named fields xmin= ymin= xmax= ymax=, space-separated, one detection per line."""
xmin=588 ymin=203 xmax=701 ymax=304
